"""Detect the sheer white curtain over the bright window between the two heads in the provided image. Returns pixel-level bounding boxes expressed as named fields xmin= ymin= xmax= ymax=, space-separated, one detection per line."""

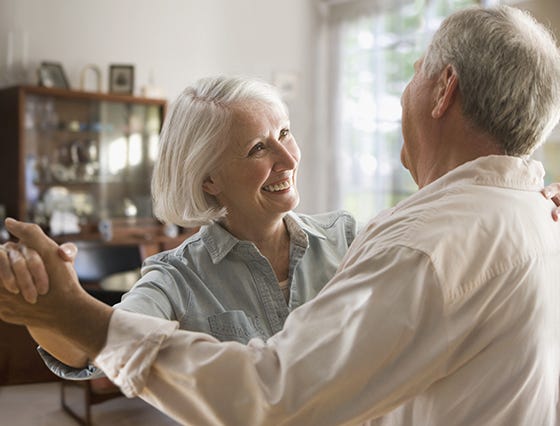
xmin=312 ymin=0 xmax=476 ymax=226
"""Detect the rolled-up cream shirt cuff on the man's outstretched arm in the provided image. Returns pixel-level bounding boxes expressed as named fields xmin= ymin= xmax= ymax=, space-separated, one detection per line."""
xmin=94 ymin=309 xmax=179 ymax=398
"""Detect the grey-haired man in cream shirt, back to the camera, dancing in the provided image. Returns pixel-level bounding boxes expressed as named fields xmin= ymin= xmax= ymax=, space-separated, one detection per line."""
xmin=0 ymin=7 xmax=560 ymax=426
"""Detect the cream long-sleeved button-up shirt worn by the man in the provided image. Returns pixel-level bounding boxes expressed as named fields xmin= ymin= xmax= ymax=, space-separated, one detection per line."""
xmin=96 ymin=156 xmax=560 ymax=426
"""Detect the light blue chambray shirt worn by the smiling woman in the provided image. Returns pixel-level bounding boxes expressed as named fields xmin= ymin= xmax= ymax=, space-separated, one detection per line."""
xmin=39 ymin=211 xmax=356 ymax=379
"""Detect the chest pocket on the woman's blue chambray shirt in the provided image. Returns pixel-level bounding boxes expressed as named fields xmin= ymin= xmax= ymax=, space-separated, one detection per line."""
xmin=208 ymin=311 xmax=269 ymax=344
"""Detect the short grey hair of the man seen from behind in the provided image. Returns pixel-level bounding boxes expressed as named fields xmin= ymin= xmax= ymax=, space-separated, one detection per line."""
xmin=423 ymin=6 xmax=560 ymax=156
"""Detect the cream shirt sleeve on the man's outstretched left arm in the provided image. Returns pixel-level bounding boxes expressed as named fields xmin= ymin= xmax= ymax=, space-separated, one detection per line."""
xmin=96 ymin=245 xmax=448 ymax=425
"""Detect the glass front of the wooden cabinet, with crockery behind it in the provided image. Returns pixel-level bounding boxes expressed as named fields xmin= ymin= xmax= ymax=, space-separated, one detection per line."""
xmin=24 ymin=93 xmax=165 ymax=234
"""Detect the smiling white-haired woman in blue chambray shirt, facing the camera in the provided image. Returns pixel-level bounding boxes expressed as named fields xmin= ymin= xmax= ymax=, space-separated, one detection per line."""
xmin=0 ymin=77 xmax=356 ymax=377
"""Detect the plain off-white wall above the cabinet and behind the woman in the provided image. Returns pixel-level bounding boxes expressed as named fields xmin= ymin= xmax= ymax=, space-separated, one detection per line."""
xmin=0 ymin=0 xmax=326 ymax=211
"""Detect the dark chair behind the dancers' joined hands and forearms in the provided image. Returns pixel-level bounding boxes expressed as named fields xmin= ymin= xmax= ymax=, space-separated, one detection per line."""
xmin=60 ymin=241 xmax=142 ymax=426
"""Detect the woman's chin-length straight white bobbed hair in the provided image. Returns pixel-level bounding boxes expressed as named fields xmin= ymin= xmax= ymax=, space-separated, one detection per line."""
xmin=152 ymin=77 xmax=288 ymax=227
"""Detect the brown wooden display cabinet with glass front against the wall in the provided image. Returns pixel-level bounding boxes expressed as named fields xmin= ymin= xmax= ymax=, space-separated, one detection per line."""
xmin=0 ymin=86 xmax=190 ymax=385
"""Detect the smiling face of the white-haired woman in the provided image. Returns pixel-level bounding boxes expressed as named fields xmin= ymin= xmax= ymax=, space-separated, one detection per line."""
xmin=204 ymin=102 xmax=300 ymax=228
